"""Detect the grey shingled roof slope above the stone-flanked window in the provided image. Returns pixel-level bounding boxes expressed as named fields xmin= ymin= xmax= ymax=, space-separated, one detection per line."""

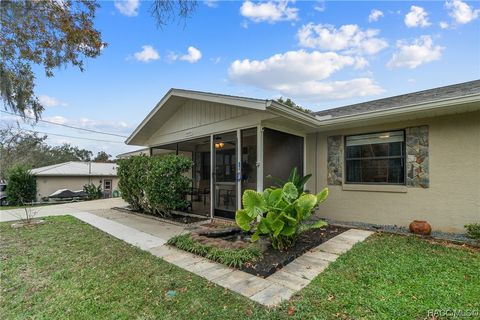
xmin=315 ymin=80 xmax=480 ymax=120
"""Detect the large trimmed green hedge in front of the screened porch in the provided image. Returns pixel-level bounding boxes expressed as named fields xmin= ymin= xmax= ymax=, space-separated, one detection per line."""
xmin=117 ymin=155 xmax=193 ymax=215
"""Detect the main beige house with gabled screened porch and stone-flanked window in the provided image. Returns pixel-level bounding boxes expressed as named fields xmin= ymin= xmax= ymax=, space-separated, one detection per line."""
xmin=126 ymin=81 xmax=480 ymax=232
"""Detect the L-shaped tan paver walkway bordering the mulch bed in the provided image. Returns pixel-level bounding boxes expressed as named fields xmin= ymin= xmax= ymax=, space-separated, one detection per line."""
xmin=148 ymin=229 xmax=373 ymax=307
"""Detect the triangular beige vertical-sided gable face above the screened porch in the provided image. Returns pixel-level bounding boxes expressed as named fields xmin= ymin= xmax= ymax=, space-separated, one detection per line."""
xmin=147 ymin=100 xmax=275 ymax=146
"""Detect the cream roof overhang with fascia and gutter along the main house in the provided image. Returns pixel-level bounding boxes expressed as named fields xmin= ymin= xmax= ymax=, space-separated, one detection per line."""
xmin=125 ymin=89 xmax=480 ymax=145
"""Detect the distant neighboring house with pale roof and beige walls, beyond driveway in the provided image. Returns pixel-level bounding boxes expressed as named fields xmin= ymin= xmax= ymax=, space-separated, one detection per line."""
xmin=31 ymin=161 xmax=118 ymax=200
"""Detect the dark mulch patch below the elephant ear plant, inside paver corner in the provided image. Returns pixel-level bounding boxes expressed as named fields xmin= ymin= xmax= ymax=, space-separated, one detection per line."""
xmin=241 ymin=225 xmax=348 ymax=277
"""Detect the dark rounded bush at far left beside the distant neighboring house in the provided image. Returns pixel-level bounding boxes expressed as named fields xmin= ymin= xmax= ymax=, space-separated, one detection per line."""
xmin=6 ymin=165 xmax=37 ymax=206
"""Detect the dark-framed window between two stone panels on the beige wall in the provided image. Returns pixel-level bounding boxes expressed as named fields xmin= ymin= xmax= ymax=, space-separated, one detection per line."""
xmin=345 ymin=131 xmax=405 ymax=184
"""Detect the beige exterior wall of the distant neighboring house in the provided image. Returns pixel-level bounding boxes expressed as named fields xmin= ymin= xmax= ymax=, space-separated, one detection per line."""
xmin=36 ymin=176 xmax=118 ymax=201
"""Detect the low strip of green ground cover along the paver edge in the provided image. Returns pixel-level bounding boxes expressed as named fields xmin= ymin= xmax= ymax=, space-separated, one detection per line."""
xmin=168 ymin=234 xmax=262 ymax=268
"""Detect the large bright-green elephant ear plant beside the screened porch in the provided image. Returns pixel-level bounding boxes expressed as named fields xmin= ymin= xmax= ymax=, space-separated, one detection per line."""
xmin=235 ymin=182 xmax=328 ymax=250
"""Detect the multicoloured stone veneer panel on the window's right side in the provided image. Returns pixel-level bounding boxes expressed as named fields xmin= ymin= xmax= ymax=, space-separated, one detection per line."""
xmin=405 ymin=126 xmax=430 ymax=188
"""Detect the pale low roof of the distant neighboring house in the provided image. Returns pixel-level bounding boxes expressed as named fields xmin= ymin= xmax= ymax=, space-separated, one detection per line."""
xmin=30 ymin=161 xmax=117 ymax=177
